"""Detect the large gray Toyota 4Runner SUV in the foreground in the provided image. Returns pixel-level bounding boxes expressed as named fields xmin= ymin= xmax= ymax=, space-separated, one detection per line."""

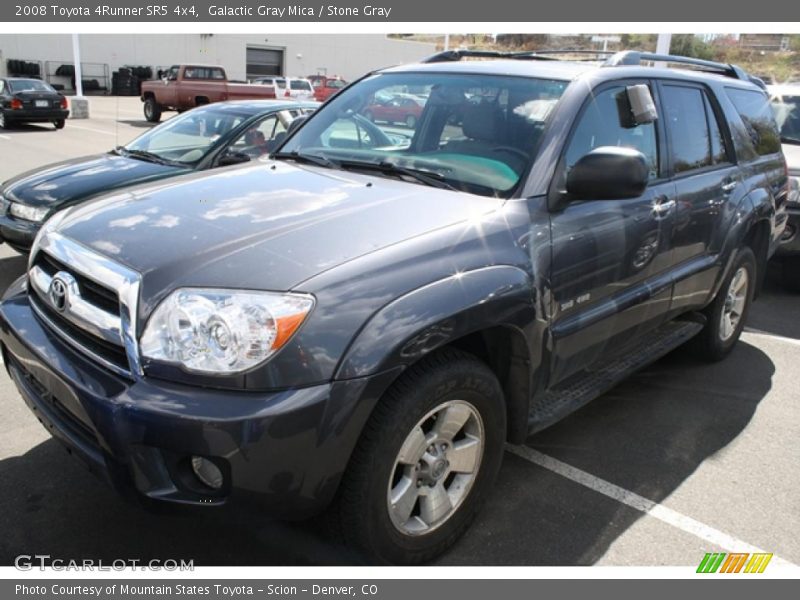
xmin=0 ymin=51 xmax=788 ymax=563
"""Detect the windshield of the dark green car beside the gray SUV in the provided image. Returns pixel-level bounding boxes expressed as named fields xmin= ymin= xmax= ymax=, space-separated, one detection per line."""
xmin=125 ymin=105 xmax=252 ymax=165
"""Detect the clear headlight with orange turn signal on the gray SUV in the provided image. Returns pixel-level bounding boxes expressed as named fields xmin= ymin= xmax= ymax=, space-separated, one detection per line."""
xmin=139 ymin=288 xmax=314 ymax=375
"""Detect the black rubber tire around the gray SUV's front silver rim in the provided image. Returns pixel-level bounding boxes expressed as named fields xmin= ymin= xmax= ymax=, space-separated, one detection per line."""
xmin=329 ymin=349 xmax=506 ymax=564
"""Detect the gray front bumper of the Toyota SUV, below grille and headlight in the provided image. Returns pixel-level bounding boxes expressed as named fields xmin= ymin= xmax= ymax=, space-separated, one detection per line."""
xmin=0 ymin=279 xmax=394 ymax=518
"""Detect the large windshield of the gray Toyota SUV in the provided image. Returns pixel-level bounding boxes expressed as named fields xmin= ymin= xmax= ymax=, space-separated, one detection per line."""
xmin=279 ymin=73 xmax=567 ymax=197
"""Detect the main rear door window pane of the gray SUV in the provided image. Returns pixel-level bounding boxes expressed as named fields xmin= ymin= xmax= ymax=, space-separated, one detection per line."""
xmin=662 ymin=85 xmax=713 ymax=173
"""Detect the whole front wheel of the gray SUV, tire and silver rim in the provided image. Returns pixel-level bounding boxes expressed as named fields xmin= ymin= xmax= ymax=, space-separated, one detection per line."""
xmin=329 ymin=349 xmax=506 ymax=564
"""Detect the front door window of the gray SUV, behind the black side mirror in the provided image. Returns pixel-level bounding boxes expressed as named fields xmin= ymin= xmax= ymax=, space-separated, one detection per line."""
xmin=566 ymin=87 xmax=658 ymax=179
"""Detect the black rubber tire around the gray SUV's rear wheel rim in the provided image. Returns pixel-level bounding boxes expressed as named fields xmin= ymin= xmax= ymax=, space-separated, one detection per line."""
xmin=692 ymin=247 xmax=757 ymax=362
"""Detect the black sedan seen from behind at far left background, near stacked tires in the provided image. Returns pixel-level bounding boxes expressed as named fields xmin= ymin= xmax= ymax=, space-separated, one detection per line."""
xmin=0 ymin=77 xmax=69 ymax=129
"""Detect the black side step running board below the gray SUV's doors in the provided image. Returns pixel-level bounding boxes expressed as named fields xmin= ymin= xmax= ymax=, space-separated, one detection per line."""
xmin=528 ymin=318 xmax=703 ymax=435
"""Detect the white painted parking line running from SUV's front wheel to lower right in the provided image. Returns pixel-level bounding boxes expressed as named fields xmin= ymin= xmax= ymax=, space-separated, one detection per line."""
xmin=506 ymin=445 xmax=795 ymax=566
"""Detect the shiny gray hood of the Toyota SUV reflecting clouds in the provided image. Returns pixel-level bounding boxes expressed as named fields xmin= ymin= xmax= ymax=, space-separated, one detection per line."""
xmin=57 ymin=161 xmax=503 ymax=311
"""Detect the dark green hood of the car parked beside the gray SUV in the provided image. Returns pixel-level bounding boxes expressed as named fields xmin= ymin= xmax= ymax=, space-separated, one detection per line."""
xmin=3 ymin=154 xmax=186 ymax=208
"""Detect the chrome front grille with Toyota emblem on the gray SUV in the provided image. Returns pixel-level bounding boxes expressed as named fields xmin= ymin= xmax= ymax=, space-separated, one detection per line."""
xmin=28 ymin=232 xmax=141 ymax=377
